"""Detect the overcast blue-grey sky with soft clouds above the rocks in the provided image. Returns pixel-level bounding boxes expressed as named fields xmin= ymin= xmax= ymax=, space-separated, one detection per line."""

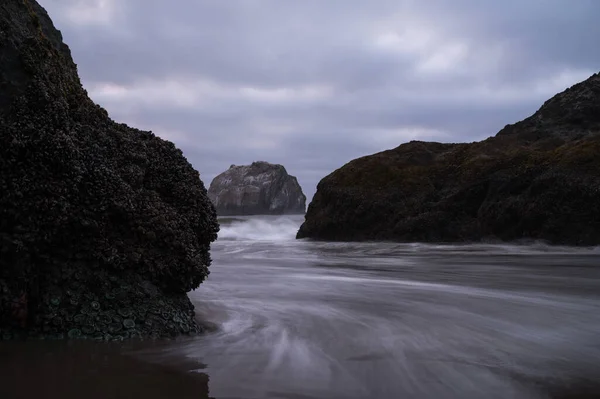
xmin=38 ymin=0 xmax=600 ymax=200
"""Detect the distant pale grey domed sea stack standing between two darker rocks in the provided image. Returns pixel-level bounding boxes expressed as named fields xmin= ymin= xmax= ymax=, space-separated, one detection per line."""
xmin=208 ymin=162 xmax=306 ymax=216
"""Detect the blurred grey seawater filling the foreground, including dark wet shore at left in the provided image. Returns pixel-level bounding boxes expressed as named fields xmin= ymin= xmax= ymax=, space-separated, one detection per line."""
xmin=0 ymin=216 xmax=600 ymax=399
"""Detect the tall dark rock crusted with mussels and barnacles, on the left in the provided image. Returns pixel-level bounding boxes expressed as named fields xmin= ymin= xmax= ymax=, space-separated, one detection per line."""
xmin=0 ymin=0 xmax=219 ymax=339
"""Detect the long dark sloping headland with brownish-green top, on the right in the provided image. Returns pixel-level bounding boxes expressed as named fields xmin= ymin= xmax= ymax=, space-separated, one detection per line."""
xmin=297 ymin=74 xmax=600 ymax=245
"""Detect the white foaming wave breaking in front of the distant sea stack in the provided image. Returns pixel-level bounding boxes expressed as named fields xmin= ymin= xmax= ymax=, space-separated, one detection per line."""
xmin=219 ymin=216 xmax=302 ymax=241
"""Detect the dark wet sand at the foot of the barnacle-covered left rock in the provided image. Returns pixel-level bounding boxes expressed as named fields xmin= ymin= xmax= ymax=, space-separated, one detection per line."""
xmin=0 ymin=341 xmax=209 ymax=399
